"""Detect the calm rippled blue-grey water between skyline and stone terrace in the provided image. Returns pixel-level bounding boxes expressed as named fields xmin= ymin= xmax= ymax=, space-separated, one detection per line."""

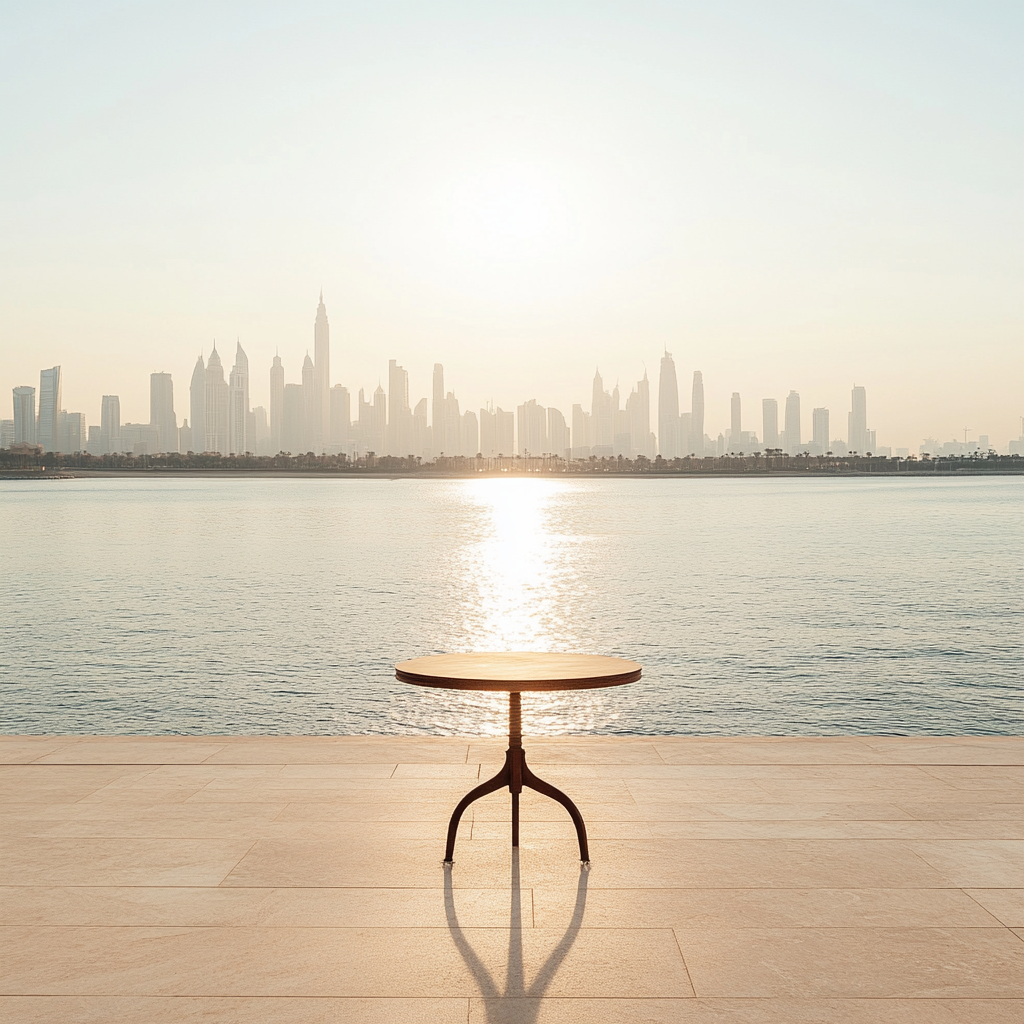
xmin=0 ymin=477 xmax=1024 ymax=735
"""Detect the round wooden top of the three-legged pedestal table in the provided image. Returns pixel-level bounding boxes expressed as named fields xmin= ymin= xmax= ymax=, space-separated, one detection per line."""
xmin=394 ymin=651 xmax=641 ymax=693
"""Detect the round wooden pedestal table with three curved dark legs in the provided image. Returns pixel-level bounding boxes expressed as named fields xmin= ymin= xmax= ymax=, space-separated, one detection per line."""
xmin=394 ymin=652 xmax=641 ymax=864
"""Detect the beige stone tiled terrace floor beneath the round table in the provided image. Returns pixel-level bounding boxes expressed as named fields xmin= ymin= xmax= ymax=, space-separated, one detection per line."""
xmin=0 ymin=737 xmax=1024 ymax=1024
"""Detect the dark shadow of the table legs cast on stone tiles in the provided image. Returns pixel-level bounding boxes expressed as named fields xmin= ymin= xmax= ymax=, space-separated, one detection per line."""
xmin=444 ymin=849 xmax=590 ymax=1024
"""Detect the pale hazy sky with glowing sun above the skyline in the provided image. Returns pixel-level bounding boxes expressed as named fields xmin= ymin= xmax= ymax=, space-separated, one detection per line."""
xmin=0 ymin=0 xmax=1024 ymax=446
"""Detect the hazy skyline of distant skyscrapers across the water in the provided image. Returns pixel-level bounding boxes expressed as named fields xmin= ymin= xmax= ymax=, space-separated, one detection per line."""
xmin=9 ymin=291 xmax=1007 ymax=460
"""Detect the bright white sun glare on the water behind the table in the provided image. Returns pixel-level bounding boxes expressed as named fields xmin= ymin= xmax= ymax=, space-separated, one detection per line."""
xmin=419 ymin=478 xmax=606 ymax=736
